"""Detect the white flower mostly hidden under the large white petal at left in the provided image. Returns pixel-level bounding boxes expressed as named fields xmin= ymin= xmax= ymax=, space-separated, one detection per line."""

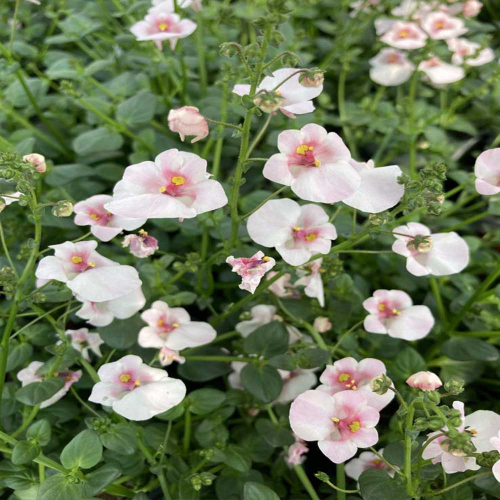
xmin=75 ymin=287 xmax=146 ymax=326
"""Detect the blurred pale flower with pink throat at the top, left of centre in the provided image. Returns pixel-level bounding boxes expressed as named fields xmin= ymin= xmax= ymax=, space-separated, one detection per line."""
xmin=130 ymin=2 xmax=196 ymax=50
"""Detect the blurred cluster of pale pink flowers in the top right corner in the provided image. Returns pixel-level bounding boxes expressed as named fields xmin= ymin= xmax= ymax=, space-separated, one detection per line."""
xmin=370 ymin=0 xmax=495 ymax=86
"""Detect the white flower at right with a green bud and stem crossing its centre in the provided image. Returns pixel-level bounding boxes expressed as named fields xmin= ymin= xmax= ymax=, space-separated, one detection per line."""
xmin=392 ymin=222 xmax=469 ymax=276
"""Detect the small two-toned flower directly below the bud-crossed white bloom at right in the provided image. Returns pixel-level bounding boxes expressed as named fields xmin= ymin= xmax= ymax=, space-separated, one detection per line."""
xmin=363 ymin=290 xmax=434 ymax=340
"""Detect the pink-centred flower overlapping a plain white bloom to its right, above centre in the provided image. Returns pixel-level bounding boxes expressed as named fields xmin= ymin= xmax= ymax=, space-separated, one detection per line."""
xmin=262 ymin=123 xmax=361 ymax=203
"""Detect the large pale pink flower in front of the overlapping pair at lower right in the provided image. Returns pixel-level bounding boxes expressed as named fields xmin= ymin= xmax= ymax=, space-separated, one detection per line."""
xmin=290 ymin=391 xmax=380 ymax=464
